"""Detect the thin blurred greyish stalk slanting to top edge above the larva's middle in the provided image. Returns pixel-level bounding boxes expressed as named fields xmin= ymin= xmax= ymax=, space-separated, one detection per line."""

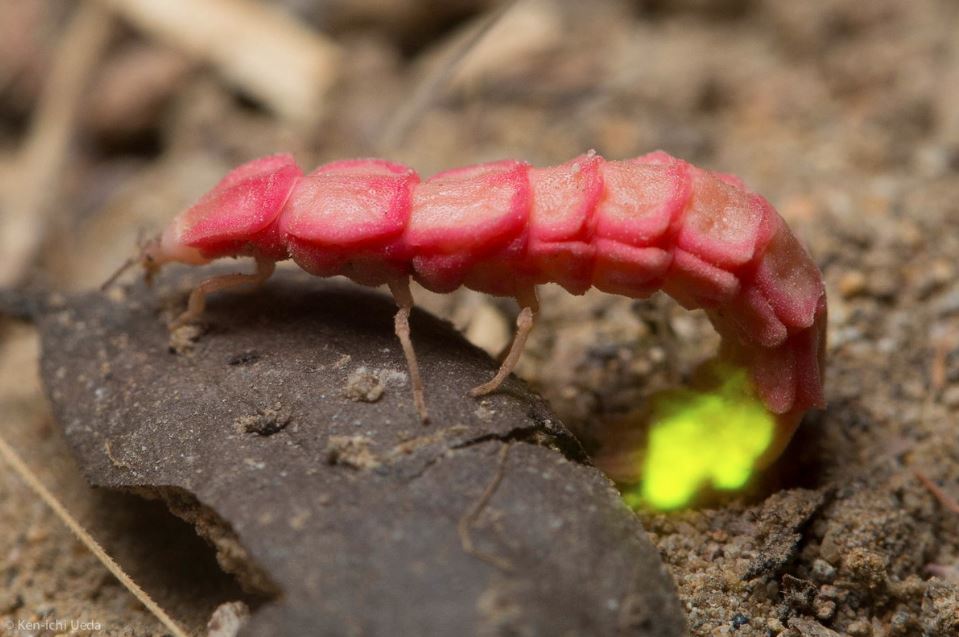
xmin=378 ymin=0 xmax=520 ymax=152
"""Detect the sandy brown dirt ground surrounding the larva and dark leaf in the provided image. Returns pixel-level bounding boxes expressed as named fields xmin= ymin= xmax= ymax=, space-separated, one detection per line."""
xmin=0 ymin=0 xmax=959 ymax=637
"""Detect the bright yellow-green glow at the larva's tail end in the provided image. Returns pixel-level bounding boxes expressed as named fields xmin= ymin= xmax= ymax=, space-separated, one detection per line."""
xmin=626 ymin=369 xmax=775 ymax=509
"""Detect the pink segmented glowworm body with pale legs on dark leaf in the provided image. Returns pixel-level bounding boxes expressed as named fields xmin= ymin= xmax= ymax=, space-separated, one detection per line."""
xmin=146 ymin=151 xmax=826 ymax=460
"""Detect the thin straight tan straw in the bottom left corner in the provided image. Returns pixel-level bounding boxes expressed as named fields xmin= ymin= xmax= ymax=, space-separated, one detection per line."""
xmin=0 ymin=428 xmax=187 ymax=637
